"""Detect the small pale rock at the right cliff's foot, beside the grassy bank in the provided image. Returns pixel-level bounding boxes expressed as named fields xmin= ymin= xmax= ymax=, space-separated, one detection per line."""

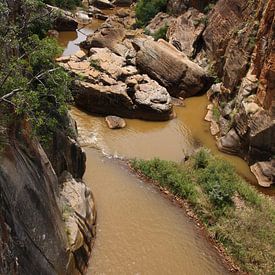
xmin=250 ymin=163 xmax=275 ymax=187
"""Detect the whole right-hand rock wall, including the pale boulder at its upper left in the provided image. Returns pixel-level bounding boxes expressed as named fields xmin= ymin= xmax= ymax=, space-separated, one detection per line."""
xmin=162 ymin=0 xmax=275 ymax=186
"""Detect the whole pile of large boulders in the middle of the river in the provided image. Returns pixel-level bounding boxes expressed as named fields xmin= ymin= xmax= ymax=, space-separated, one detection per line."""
xmin=57 ymin=9 xmax=210 ymax=120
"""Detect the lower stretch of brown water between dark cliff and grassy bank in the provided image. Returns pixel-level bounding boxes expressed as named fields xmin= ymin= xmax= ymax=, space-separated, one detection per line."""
xmin=84 ymin=148 xmax=231 ymax=275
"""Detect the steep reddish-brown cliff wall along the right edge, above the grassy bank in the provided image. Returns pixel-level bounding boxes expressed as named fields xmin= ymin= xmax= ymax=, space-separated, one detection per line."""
xmin=203 ymin=0 xmax=275 ymax=186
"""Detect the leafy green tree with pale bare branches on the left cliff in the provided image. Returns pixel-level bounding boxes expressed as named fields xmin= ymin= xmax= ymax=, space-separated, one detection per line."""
xmin=0 ymin=0 xmax=71 ymax=147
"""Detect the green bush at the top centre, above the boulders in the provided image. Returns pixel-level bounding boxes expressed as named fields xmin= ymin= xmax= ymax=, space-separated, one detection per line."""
xmin=136 ymin=0 xmax=167 ymax=27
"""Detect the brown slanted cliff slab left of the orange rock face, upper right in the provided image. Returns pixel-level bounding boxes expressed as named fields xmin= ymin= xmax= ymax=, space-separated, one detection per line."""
xmin=203 ymin=0 xmax=265 ymax=89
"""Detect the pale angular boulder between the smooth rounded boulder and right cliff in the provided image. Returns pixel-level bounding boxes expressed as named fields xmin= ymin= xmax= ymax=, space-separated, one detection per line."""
xmin=167 ymin=8 xmax=205 ymax=57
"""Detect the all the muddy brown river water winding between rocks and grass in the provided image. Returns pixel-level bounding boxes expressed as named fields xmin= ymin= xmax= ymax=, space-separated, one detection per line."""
xmin=59 ymin=14 xmax=274 ymax=275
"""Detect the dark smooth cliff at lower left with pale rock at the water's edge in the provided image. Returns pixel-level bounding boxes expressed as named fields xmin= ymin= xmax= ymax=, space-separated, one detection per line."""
xmin=0 ymin=111 xmax=95 ymax=274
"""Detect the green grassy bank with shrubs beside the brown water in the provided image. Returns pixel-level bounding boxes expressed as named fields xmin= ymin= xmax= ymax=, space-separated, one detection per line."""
xmin=131 ymin=149 xmax=275 ymax=274
